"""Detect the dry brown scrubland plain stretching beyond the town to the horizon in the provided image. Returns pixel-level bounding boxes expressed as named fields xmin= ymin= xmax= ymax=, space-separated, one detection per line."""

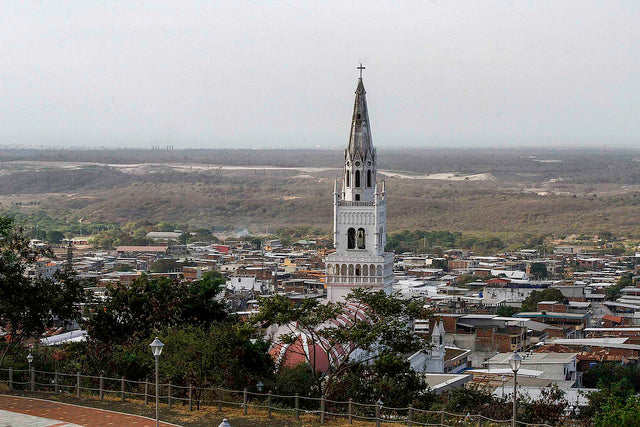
xmin=0 ymin=150 xmax=640 ymax=235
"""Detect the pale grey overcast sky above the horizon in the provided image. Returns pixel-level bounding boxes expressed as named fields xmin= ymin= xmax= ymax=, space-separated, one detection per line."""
xmin=0 ymin=0 xmax=640 ymax=148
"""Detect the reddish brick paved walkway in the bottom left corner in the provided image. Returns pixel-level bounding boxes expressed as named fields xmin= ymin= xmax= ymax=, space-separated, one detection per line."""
xmin=0 ymin=395 xmax=178 ymax=427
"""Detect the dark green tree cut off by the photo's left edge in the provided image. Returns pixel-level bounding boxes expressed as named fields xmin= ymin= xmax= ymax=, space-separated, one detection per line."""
xmin=0 ymin=217 xmax=85 ymax=366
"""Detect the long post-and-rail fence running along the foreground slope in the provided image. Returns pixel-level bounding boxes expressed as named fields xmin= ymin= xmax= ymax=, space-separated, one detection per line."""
xmin=0 ymin=368 xmax=551 ymax=427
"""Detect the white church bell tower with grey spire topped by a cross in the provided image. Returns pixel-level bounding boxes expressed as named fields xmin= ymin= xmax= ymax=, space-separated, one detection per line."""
xmin=325 ymin=64 xmax=393 ymax=301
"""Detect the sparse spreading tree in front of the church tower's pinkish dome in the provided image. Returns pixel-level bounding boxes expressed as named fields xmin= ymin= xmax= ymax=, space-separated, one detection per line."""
xmin=254 ymin=289 xmax=428 ymax=396
